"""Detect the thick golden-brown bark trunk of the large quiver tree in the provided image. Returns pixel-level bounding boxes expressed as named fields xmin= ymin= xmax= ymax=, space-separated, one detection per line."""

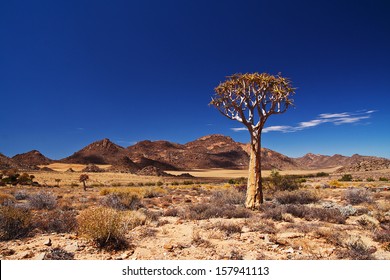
xmin=245 ymin=135 xmax=264 ymax=210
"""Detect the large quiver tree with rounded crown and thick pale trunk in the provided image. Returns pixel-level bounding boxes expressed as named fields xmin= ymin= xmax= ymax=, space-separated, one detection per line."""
xmin=210 ymin=73 xmax=295 ymax=209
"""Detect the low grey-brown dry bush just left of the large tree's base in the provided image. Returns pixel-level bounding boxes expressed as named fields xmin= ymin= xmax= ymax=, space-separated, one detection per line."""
xmin=179 ymin=203 xmax=251 ymax=220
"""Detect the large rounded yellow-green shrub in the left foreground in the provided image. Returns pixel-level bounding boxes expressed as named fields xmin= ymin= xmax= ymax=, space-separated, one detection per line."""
xmin=77 ymin=207 xmax=129 ymax=249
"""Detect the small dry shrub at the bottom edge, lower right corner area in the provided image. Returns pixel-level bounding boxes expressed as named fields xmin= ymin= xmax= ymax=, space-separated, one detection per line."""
xmin=337 ymin=238 xmax=376 ymax=260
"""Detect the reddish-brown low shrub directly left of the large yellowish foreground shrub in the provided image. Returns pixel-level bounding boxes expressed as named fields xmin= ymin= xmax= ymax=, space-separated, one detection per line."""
xmin=34 ymin=209 xmax=77 ymax=233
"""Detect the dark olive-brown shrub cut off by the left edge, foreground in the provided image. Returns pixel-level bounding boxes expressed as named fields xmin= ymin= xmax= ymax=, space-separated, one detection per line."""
xmin=0 ymin=206 xmax=32 ymax=240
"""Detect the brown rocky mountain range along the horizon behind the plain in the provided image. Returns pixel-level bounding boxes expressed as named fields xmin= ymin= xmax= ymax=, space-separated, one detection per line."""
xmin=0 ymin=134 xmax=390 ymax=173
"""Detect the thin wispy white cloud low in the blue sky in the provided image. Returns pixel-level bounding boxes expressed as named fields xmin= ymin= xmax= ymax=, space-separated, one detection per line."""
xmin=232 ymin=110 xmax=376 ymax=133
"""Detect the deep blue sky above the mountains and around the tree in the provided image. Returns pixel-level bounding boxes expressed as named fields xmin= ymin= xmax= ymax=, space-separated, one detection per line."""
xmin=0 ymin=0 xmax=390 ymax=159
